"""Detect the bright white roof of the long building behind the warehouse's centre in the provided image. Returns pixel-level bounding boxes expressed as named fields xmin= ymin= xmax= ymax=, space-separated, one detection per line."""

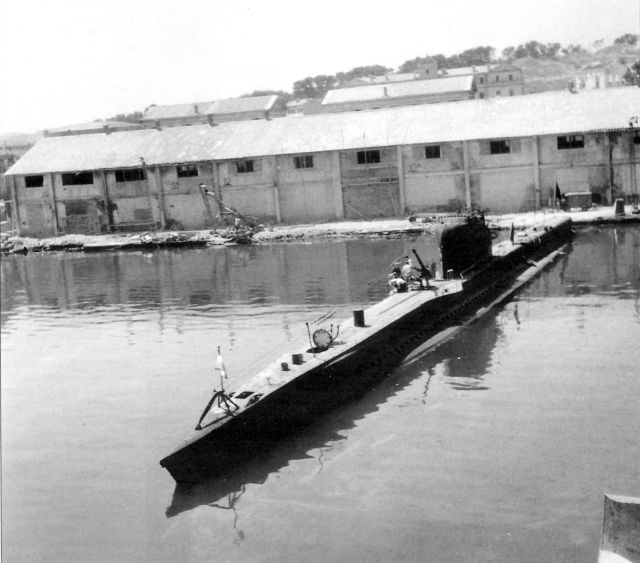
xmin=322 ymin=76 xmax=473 ymax=105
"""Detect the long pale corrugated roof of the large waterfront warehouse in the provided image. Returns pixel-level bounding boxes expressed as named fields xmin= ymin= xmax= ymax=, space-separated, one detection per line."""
xmin=8 ymin=87 xmax=640 ymax=175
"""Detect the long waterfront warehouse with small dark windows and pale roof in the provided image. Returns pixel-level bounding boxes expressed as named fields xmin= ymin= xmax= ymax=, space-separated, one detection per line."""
xmin=6 ymin=87 xmax=640 ymax=236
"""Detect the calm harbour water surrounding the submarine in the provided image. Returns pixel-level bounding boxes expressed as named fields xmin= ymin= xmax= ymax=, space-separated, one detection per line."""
xmin=1 ymin=227 xmax=640 ymax=563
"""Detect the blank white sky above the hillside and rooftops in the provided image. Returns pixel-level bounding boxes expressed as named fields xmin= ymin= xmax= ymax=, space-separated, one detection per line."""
xmin=0 ymin=0 xmax=640 ymax=133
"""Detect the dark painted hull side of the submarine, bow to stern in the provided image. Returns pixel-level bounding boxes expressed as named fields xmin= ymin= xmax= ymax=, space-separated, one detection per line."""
xmin=160 ymin=218 xmax=571 ymax=483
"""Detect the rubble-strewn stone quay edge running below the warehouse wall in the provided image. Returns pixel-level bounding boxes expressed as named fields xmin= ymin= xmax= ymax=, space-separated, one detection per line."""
xmin=1 ymin=206 xmax=640 ymax=254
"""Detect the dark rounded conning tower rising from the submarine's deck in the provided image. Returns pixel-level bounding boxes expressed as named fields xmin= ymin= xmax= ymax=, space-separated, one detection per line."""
xmin=436 ymin=215 xmax=492 ymax=278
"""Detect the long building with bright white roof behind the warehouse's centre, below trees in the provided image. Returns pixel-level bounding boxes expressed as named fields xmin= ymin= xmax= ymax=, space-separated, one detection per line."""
xmin=322 ymin=76 xmax=475 ymax=113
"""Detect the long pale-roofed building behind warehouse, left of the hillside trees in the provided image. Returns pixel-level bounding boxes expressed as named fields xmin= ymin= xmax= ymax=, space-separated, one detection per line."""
xmin=141 ymin=95 xmax=287 ymax=127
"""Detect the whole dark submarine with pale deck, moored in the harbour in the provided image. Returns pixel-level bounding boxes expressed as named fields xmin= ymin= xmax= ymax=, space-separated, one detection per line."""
xmin=160 ymin=216 xmax=572 ymax=483
